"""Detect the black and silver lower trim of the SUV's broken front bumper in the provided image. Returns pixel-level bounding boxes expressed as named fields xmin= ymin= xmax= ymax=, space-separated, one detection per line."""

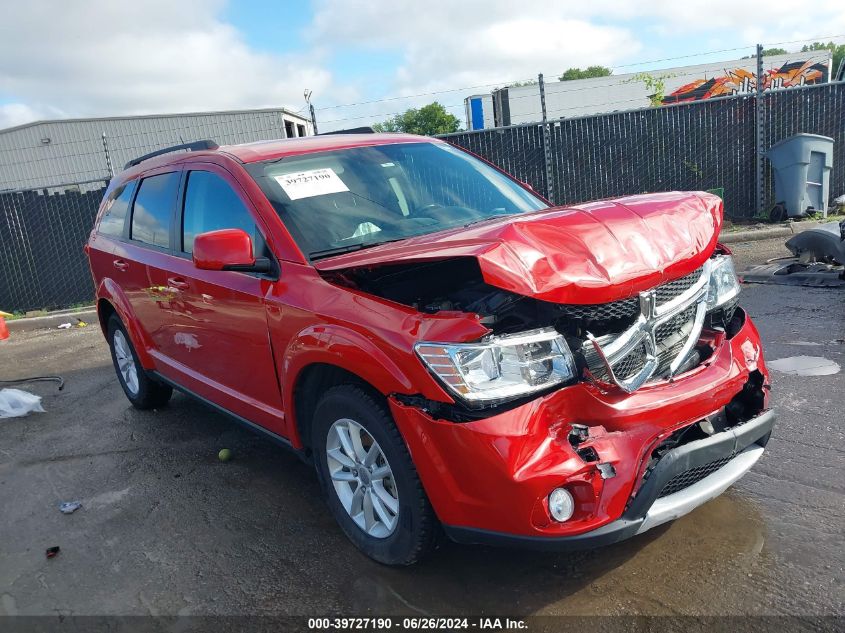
xmin=443 ymin=410 xmax=775 ymax=550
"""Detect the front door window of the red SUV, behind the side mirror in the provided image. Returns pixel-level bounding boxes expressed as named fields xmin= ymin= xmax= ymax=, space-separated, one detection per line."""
xmin=182 ymin=171 xmax=264 ymax=257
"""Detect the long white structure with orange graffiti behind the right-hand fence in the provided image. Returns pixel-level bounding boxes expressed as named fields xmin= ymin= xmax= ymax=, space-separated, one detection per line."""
xmin=465 ymin=50 xmax=836 ymax=130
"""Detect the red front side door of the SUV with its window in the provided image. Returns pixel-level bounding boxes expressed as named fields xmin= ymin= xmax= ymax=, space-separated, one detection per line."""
xmin=151 ymin=163 xmax=284 ymax=433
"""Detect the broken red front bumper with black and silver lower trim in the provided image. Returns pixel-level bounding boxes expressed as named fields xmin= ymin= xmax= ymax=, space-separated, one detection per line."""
xmin=390 ymin=306 xmax=774 ymax=548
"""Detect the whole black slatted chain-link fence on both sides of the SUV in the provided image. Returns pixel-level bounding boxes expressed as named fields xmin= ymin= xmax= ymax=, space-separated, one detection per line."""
xmin=0 ymin=82 xmax=845 ymax=310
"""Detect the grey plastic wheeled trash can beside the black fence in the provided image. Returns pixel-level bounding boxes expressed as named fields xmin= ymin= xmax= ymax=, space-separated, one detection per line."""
xmin=766 ymin=134 xmax=833 ymax=220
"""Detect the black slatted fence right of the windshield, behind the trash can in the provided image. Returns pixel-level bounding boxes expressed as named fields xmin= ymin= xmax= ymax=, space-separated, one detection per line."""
xmin=442 ymin=83 xmax=845 ymax=219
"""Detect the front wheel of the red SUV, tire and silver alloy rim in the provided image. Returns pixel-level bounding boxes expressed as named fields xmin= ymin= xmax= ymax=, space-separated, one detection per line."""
xmin=311 ymin=385 xmax=436 ymax=565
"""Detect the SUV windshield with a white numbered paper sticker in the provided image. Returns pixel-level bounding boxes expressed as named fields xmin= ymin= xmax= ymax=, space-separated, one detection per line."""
xmin=246 ymin=143 xmax=548 ymax=259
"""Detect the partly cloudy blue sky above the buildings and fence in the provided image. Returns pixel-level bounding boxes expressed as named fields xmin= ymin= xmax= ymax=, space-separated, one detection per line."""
xmin=0 ymin=0 xmax=845 ymax=131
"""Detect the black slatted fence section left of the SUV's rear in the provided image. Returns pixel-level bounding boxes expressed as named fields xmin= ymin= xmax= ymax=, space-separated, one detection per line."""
xmin=0 ymin=180 xmax=108 ymax=311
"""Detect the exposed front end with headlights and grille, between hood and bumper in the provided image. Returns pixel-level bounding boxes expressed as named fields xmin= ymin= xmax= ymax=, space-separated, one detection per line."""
xmin=327 ymin=250 xmax=739 ymax=420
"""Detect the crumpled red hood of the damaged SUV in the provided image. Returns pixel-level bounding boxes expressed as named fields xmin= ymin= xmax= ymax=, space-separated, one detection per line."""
xmin=315 ymin=192 xmax=722 ymax=304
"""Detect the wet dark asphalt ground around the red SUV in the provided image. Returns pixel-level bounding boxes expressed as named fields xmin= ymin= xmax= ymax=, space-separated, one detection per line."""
xmin=0 ymin=240 xmax=845 ymax=616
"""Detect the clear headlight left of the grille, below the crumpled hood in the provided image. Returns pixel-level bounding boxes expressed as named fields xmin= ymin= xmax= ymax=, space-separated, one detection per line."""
xmin=414 ymin=328 xmax=575 ymax=403
